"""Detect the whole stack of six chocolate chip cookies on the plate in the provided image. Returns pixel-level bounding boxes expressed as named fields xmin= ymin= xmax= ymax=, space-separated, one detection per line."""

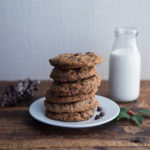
xmin=45 ymin=52 xmax=104 ymax=121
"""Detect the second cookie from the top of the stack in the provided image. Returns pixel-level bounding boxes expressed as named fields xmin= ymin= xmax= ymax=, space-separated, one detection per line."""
xmin=50 ymin=66 xmax=97 ymax=83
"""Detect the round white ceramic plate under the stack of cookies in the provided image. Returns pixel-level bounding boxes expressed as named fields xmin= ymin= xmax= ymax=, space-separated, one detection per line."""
xmin=29 ymin=95 xmax=120 ymax=128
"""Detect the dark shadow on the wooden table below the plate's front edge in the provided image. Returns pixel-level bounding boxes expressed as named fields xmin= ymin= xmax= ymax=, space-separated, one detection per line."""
xmin=26 ymin=112 xmax=123 ymax=139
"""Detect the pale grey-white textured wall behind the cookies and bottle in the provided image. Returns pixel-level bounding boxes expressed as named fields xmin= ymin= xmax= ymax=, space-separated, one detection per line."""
xmin=0 ymin=0 xmax=150 ymax=80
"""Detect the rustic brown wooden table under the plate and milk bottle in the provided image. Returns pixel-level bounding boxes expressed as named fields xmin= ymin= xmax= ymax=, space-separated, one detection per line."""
xmin=0 ymin=81 xmax=150 ymax=150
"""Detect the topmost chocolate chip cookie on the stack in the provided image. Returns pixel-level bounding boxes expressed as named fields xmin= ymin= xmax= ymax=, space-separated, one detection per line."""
xmin=49 ymin=52 xmax=104 ymax=69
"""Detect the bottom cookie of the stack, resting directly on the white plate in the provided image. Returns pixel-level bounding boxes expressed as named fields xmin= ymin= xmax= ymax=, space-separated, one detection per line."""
xmin=46 ymin=109 xmax=95 ymax=121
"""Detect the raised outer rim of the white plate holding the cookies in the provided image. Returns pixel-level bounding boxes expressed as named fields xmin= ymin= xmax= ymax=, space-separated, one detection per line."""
xmin=29 ymin=95 xmax=120 ymax=128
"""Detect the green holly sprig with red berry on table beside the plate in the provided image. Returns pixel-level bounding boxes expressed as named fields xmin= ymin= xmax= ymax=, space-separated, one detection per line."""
xmin=114 ymin=108 xmax=150 ymax=126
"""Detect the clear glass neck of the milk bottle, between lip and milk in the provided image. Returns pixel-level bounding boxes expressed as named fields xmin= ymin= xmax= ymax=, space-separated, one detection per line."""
xmin=113 ymin=34 xmax=137 ymax=50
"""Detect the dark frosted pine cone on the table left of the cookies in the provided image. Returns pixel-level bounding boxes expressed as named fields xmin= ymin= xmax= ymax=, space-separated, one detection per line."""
xmin=0 ymin=78 xmax=40 ymax=107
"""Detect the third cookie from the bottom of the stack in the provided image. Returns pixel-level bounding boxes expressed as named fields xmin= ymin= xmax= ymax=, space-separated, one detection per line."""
xmin=45 ymin=89 xmax=97 ymax=103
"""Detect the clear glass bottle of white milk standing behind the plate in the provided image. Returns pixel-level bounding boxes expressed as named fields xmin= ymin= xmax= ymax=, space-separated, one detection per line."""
xmin=109 ymin=27 xmax=141 ymax=102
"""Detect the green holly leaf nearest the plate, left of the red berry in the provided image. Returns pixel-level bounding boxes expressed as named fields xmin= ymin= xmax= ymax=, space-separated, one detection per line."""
xmin=114 ymin=108 xmax=131 ymax=122
